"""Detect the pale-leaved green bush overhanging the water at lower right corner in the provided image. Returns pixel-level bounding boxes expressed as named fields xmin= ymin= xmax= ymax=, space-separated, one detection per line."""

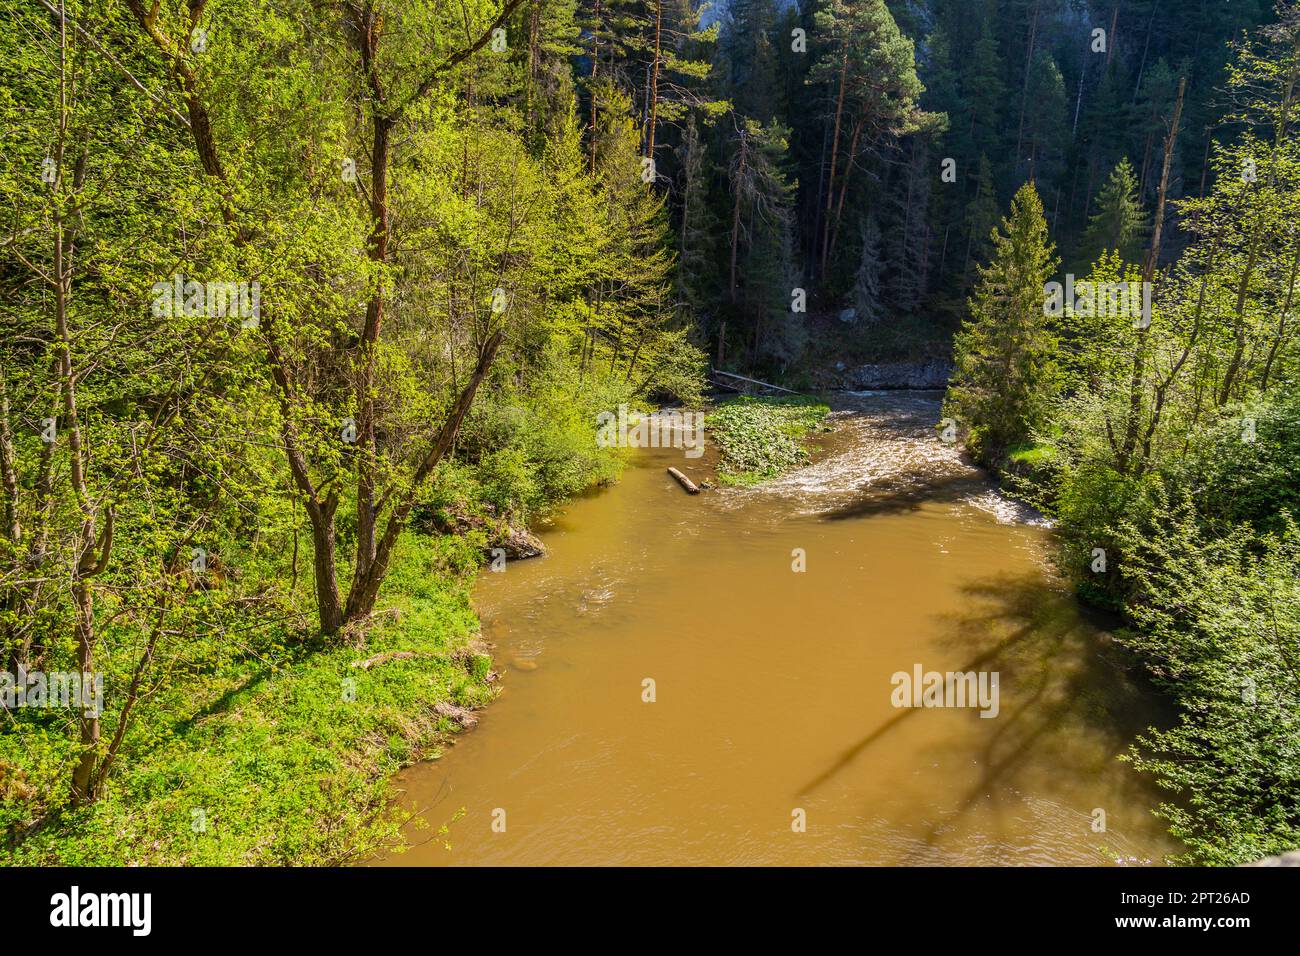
xmin=1121 ymin=498 xmax=1300 ymax=866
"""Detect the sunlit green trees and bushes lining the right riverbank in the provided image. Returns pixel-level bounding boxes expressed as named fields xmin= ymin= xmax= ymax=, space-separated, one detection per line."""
xmin=949 ymin=3 xmax=1300 ymax=865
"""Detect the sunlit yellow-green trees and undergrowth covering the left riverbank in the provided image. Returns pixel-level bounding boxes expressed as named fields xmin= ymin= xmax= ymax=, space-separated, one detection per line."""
xmin=0 ymin=0 xmax=710 ymax=864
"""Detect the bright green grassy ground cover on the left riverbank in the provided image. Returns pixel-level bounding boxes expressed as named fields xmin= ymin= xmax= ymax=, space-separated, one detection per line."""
xmin=0 ymin=535 xmax=493 ymax=865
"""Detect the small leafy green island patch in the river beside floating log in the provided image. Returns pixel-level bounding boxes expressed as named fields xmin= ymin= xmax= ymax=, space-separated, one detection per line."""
xmin=706 ymin=395 xmax=831 ymax=485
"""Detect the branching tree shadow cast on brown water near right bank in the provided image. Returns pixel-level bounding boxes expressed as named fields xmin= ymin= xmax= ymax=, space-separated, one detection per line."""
xmin=801 ymin=570 xmax=1170 ymax=864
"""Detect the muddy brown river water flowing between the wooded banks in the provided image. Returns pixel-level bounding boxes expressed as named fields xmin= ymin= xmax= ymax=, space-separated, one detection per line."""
xmin=384 ymin=393 xmax=1175 ymax=865
